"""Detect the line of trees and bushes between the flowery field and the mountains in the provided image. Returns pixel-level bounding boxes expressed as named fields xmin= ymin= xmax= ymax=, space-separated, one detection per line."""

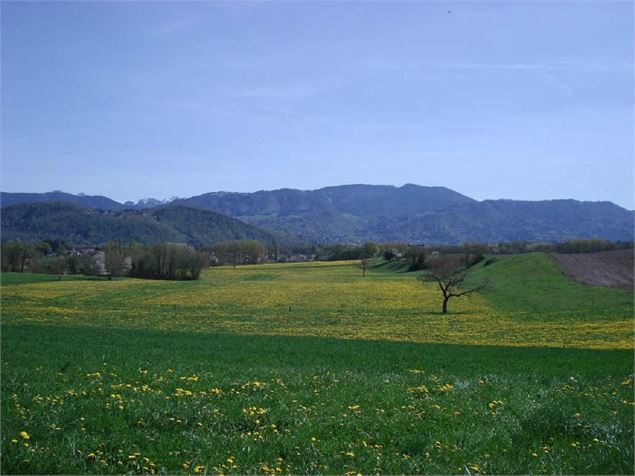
xmin=1 ymin=239 xmax=633 ymax=279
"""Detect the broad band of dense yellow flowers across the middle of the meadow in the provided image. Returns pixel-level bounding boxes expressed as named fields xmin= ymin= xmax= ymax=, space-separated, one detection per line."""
xmin=2 ymin=262 xmax=634 ymax=350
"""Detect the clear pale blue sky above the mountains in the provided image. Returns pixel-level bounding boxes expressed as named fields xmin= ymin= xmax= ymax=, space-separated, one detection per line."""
xmin=0 ymin=0 xmax=635 ymax=209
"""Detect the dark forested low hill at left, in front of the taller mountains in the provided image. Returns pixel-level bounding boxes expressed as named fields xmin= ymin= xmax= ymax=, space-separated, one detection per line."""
xmin=2 ymin=202 xmax=299 ymax=246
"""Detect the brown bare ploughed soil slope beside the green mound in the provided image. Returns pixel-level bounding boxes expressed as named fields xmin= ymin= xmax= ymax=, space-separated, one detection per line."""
xmin=551 ymin=249 xmax=635 ymax=290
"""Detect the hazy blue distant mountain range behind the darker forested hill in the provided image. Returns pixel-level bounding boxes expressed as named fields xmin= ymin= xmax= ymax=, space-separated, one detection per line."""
xmin=0 ymin=184 xmax=634 ymax=244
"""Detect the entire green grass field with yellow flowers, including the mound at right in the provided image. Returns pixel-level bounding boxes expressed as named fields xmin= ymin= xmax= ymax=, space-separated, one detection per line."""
xmin=1 ymin=254 xmax=634 ymax=474
